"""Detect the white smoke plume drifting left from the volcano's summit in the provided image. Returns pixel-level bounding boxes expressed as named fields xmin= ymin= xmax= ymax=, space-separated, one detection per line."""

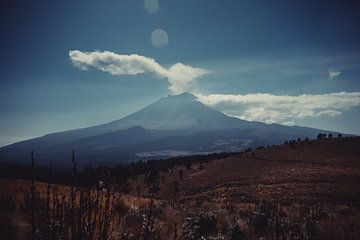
xmin=69 ymin=50 xmax=208 ymax=94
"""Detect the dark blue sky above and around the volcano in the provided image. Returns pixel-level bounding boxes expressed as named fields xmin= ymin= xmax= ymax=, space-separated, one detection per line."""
xmin=0 ymin=0 xmax=360 ymax=145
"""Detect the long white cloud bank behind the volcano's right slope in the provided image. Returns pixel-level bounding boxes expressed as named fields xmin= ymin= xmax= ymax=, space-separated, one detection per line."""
xmin=197 ymin=92 xmax=360 ymax=124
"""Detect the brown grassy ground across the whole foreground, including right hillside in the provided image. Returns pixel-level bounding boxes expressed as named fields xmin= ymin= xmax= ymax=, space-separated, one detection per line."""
xmin=0 ymin=137 xmax=360 ymax=239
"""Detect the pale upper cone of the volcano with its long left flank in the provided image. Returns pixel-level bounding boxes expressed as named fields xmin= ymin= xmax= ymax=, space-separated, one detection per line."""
xmin=0 ymin=93 xmax=262 ymax=152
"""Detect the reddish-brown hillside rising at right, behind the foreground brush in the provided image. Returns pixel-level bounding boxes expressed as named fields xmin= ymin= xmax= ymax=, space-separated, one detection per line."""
xmin=164 ymin=137 xmax=360 ymax=204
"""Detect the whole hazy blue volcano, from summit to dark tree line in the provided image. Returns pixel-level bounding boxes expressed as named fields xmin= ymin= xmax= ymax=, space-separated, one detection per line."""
xmin=0 ymin=93 xmax=340 ymax=165
